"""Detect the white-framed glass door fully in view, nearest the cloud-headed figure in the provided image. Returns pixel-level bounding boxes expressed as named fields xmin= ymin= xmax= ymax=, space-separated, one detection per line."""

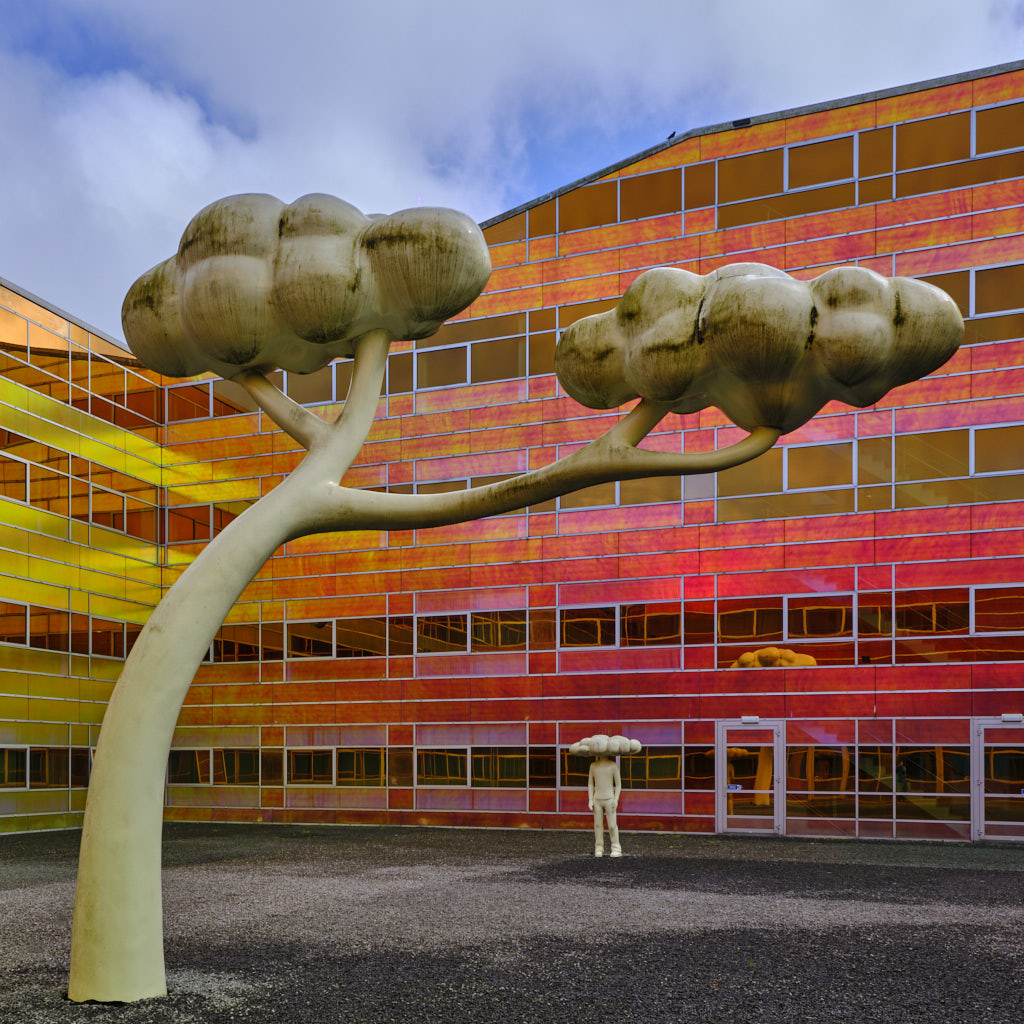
xmin=715 ymin=722 xmax=785 ymax=836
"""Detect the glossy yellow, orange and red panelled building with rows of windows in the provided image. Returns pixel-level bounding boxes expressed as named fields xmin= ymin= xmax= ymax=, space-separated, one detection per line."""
xmin=0 ymin=61 xmax=1024 ymax=839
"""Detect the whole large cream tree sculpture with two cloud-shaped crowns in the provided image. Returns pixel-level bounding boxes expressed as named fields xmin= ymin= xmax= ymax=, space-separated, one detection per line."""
xmin=69 ymin=195 xmax=963 ymax=1001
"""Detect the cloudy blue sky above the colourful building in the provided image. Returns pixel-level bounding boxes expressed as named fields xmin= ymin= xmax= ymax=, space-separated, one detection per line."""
xmin=0 ymin=0 xmax=1024 ymax=339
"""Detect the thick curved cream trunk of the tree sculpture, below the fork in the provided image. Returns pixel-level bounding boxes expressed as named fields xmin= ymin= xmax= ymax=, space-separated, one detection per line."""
xmin=68 ymin=472 xmax=304 ymax=1001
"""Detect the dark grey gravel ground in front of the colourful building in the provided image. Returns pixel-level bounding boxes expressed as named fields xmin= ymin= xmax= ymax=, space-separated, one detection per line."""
xmin=0 ymin=824 xmax=1024 ymax=1024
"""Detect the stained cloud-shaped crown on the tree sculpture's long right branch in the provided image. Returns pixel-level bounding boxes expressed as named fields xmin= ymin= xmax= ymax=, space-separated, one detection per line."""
xmin=555 ymin=263 xmax=964 ymax=433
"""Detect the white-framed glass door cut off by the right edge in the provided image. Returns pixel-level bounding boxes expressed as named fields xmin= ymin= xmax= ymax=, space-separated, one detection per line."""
xmin=971 ymin=716 xmax=1024 ymax=840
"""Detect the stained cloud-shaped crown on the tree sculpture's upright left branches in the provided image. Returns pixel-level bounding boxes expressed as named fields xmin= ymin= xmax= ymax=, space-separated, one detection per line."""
xmin=121 ymin=195 xmax=490 ymax=377
